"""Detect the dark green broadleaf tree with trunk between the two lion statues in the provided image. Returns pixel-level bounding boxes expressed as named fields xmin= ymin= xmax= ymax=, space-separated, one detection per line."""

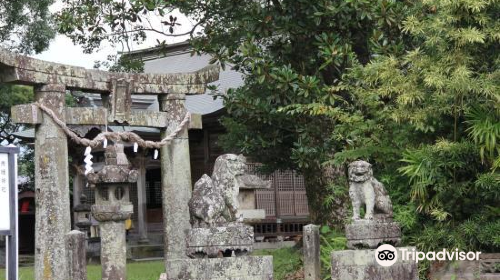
xmin=59 ymin=0 xmax=407 ymax=222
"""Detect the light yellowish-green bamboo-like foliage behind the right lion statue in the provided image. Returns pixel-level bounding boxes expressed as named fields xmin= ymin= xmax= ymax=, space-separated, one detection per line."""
xmin=312 ymin=0 xmax=500 ymax=252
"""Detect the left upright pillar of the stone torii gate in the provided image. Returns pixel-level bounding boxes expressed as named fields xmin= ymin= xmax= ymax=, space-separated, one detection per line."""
xmin=35 ymin=85 xmax=71 ymax=280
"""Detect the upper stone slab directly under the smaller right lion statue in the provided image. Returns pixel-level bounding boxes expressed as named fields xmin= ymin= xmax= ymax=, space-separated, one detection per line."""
xmin=345 ymin=220 xmax=401 ymax=249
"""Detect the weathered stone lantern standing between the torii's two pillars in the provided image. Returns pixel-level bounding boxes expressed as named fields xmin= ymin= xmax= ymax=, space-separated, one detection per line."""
xmin=87 ymin=144 xmax=138 ymax=280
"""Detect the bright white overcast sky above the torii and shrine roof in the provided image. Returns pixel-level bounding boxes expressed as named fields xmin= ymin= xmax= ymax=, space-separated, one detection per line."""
xmin=34 ymin=1 xmax=192 ymax=68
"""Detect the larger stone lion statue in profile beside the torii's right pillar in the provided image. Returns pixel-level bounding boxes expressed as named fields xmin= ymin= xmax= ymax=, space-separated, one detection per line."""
xmin=189 ymin=154 xmax=246 ymax=228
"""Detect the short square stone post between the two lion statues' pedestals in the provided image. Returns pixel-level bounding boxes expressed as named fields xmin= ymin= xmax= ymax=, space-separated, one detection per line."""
xmin=302 ymin=225 xmax=321 ymax=280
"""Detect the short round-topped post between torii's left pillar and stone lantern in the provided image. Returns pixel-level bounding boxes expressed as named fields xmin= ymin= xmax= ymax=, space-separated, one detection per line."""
xmin=66 ymin=230 xmax=87 ymax=280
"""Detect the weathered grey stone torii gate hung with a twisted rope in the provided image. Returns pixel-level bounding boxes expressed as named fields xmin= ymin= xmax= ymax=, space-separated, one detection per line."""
xmin=0 ymin=49 xmax=219 ymax=280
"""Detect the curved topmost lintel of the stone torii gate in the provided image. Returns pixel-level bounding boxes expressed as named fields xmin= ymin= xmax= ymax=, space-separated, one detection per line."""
xmin=0 ymin=48 xmax=219 ymax=94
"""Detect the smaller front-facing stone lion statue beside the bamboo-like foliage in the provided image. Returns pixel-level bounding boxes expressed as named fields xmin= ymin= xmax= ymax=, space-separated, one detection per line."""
xmin=348 ymin=160 xmax=392 ymax=220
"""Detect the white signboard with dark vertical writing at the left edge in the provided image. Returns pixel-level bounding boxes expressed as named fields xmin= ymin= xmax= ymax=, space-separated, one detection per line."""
xmin=0 ymin=153 xmax=11 ymax=230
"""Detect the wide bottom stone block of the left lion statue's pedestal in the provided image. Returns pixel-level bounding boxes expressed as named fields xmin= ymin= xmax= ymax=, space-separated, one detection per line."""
xmin=160 ymin=256 xmax=273 ymax=280
